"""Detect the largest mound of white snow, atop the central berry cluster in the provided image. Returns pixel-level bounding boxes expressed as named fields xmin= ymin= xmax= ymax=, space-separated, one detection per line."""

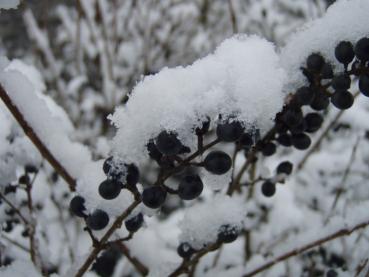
xmin=110 ymin=35 xmax=286 ymax=162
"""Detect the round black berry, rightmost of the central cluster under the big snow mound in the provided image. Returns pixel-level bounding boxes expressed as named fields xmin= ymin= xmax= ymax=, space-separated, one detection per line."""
xmin=204 ymin=151 xmax=232 ymax=175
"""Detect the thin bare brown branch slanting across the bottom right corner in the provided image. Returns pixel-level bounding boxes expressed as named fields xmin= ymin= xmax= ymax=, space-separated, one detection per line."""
xmin=243 ymin=218 xmax=369 ymax=277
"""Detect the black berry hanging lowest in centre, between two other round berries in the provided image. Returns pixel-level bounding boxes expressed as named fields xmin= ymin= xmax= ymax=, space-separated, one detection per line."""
xmin=178 ymin=174 xmax=204 ymax=200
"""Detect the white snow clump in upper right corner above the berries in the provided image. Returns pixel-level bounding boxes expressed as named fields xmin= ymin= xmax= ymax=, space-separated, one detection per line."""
xmin=280 ymin=0 xmax=369 ymax=90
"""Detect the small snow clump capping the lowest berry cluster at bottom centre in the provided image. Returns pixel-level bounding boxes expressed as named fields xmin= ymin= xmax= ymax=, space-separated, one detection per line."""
xmin=179 ymin=195 xmax=246 ymax=249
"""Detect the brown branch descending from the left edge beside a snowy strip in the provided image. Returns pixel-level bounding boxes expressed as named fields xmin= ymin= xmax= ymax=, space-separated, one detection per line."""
xmin=0 ymin=84 xmax=76 ymax=191
